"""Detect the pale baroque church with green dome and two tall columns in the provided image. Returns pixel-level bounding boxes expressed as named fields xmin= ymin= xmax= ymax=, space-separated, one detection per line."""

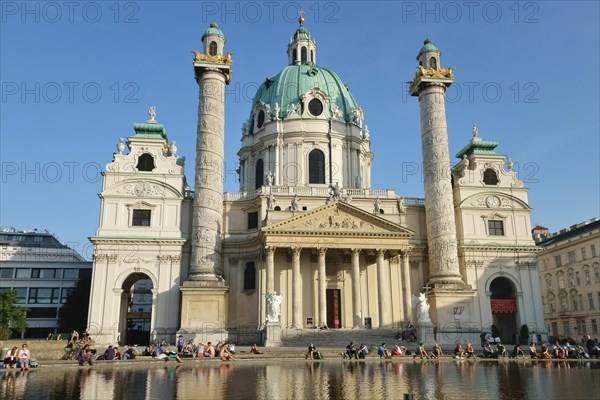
xmin=88 ymin=18 xmax=545 ymax=345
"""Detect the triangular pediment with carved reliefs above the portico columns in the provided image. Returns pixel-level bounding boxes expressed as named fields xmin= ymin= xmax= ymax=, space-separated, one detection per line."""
xmin=262 ymin=201 xmax=415 ymax=238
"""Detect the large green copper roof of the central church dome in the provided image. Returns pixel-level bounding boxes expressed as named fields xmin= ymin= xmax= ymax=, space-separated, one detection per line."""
xmin=250 ymin=64 xmax=358 ymax=121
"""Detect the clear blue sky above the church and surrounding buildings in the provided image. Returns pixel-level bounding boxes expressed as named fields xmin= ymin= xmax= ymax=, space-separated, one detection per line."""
xmin=0 ymin=1 xmax=600 ymax=258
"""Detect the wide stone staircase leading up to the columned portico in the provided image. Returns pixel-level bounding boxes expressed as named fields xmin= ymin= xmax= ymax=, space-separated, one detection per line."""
xmin=281 ymin=329 xmax=416 ymax=351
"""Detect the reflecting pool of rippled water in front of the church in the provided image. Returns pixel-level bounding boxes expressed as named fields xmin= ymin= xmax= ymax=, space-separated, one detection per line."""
xmin=0 ymin=360 xmax=600 ymax=400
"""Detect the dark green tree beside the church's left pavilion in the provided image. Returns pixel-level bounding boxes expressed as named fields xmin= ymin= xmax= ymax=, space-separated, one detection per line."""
xmin=58 ymin=271 xmax=92 ymax=333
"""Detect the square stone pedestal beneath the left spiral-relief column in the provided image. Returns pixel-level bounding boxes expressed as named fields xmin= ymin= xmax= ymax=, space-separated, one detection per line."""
xmin=177 ymin=282 xmax=229 ymax=344
